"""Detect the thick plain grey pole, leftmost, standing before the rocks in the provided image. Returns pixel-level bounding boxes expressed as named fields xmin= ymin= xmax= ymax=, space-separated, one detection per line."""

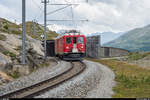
xmin=22 ymin=0 xmax=26 ymax=65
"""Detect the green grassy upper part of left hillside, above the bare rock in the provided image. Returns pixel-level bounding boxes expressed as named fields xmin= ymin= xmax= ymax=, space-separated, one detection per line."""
xmin=0 ymin=18 xmax=58 ymax=39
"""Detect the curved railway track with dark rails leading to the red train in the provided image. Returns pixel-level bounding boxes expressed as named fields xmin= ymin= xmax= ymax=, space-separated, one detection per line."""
xmin=0 ymin=62 xmax=86 ymax=98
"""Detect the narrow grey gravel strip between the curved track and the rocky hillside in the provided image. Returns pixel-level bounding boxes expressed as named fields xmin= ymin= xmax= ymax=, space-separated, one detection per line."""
xmin=0 ymin=61 xmax=71 ymax=95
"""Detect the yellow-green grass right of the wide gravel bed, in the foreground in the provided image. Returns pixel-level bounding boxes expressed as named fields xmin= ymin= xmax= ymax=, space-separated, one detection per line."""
xmin=88 ymin=58 xmax=150 ymax=98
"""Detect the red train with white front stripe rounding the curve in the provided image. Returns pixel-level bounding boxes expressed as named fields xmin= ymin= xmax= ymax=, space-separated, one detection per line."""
xmin=55 ymin=30 xmax=86 ymax=60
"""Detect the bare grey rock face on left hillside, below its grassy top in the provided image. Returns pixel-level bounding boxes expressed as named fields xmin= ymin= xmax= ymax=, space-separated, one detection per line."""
xmin=0 ymin=33 xmax=44 ymax=82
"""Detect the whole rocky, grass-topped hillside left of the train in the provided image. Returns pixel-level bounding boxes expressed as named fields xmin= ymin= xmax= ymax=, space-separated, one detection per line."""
xmin=0 ymin=18 xmax=57 ymax=85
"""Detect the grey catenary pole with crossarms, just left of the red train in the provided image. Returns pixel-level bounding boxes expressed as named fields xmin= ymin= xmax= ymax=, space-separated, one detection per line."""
xmin=42 ymin=0 xmax=49 ymax=60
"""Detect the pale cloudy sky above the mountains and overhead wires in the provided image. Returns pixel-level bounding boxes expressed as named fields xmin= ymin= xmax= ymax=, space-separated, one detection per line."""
xmin=0 ymin=0 xmax=150 ymax=33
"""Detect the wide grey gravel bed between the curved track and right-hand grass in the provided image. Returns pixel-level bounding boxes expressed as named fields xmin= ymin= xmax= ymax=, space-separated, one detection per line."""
xmin=35 ymin=61 xmax=115 ymax=98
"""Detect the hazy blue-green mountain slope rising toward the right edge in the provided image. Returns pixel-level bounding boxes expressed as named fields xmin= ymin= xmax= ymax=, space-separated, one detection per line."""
xmin=104 ymin=25 xmax=150 ymax=51
